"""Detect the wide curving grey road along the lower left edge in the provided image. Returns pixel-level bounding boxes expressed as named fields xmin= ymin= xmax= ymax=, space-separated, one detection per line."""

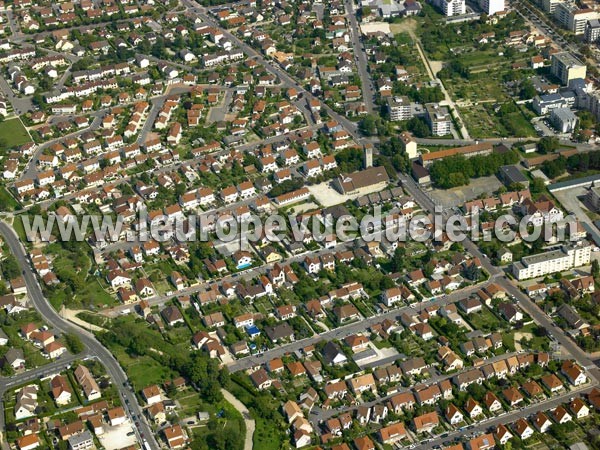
xmin=0 ymin=222 xmax=160 ymax=450
